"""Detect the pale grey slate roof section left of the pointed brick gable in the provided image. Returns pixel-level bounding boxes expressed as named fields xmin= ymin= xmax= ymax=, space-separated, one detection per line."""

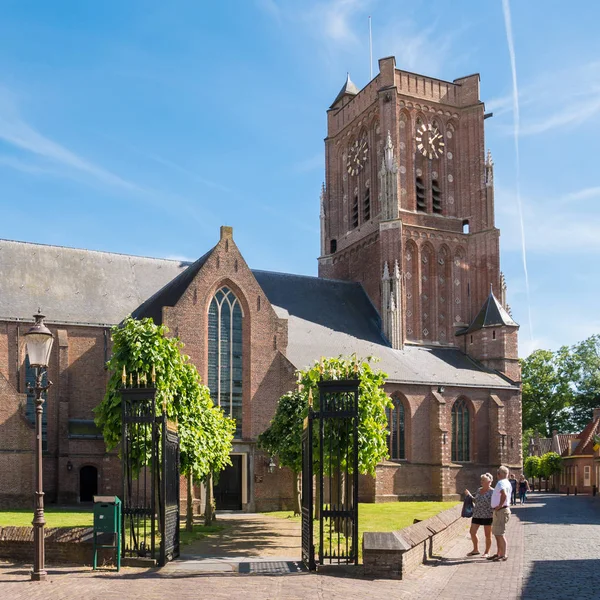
xmin=0 ymin=240 xmax=190 ymax=325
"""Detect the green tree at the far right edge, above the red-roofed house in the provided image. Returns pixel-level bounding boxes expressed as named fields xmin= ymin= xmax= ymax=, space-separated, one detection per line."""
xmin=565 ymin=334 xmax=600 ymax=432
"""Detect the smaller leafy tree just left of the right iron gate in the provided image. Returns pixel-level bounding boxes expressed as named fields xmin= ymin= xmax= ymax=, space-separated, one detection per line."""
xmin=258 ymin=391 xmax=308 ymax=515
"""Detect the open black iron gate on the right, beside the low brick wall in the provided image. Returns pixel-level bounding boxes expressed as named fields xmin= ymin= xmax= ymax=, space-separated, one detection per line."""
xmin=302 ymin=379 xmax=360 ymax=570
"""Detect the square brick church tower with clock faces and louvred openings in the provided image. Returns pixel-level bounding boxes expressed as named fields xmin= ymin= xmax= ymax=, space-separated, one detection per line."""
xmin=319 ymin=57 xmax=502 ymax=358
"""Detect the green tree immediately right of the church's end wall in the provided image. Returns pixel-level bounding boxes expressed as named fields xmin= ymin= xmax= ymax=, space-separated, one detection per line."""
xmin=521 ymin=347 xmax=573 ymax=437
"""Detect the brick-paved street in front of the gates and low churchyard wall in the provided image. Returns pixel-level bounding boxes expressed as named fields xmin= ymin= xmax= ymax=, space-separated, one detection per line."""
xmin=0 ymin=494 xmax=600 ymax=600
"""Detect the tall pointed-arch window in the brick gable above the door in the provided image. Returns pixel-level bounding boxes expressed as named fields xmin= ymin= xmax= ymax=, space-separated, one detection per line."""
xmin=208 ymin=287 xmax=242 ymax=439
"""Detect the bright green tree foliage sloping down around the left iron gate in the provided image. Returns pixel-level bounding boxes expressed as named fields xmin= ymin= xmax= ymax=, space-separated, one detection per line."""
xmin=94 ymin=317 xmax=235 ymax=524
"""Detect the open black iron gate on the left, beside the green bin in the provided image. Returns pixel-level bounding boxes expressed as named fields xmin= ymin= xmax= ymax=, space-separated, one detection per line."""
xmin=121 ymin=387 xmax=179 ymax=566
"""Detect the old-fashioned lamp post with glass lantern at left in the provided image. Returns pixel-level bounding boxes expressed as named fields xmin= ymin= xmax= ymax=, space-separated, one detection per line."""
xmin=24 ymin=311 xmax=54 ymax=581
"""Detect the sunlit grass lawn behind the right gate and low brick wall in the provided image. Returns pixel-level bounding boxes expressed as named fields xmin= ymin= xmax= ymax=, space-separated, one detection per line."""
xmin=266 ymin=502 xmax=458 ymax=562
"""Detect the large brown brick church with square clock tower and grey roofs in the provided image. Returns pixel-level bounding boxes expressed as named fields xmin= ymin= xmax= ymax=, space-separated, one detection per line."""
xmin=0 ymin=57 xmax=522 ymax=511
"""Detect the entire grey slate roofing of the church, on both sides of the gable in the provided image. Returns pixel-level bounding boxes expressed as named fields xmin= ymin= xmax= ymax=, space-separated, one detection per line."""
xmin=0 ymin=240 xmax=515 ymax=389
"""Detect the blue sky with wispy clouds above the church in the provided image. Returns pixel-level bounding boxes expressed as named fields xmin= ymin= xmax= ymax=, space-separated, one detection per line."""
xmin=0 ymin=0 xmax=600 ymax=355
